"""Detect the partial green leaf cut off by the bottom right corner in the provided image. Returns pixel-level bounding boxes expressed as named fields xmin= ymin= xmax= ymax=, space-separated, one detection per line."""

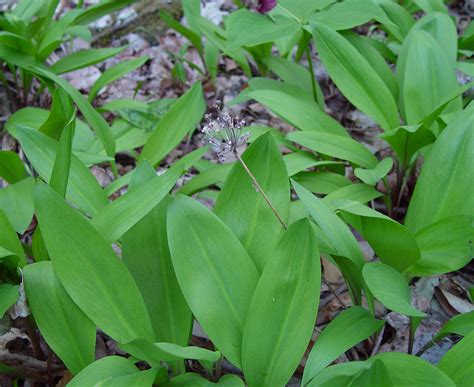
xmin=438 ymin=332 xmax=474 ymax=386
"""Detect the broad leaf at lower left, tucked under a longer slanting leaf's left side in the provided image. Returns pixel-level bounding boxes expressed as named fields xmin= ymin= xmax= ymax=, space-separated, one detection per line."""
xmin=23 ymin=262 xmax=96 ymax=374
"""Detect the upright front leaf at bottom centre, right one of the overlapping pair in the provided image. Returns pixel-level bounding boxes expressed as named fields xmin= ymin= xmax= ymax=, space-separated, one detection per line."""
xmin=242 ymin=219 xmax=321 ymax=386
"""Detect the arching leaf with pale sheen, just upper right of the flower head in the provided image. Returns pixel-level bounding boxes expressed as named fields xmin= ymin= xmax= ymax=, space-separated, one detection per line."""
xmin=244 ymin=78 xmax=348 ymax=136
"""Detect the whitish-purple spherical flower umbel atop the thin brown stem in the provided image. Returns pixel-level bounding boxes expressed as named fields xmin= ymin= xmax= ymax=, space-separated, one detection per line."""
xmin=202 ymin=101 xmax=250 ymax=162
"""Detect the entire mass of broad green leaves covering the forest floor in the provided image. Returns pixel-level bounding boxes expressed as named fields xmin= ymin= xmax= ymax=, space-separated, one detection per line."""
xmin=0 ymin=0 xmax=474 ymax=386
